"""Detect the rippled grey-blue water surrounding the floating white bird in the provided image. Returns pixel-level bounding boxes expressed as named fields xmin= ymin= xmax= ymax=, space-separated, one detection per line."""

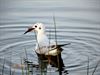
xmin=0 ymin=0 xmax=100 ymax=75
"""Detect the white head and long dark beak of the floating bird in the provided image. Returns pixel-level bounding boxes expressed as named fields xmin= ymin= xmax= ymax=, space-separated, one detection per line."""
xmin=24 ymin=23 xmax=45 ymax=34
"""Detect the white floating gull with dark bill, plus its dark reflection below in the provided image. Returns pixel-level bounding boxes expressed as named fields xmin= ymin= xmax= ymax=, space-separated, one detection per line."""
xmin=24 ymin=23 xmax=68 ymax=71
